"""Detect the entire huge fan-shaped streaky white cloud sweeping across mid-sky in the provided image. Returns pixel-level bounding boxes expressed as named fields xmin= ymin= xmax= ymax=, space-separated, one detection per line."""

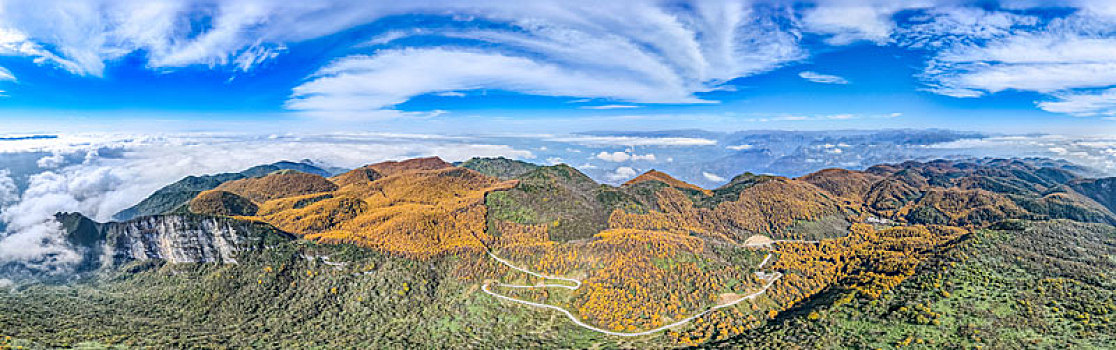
xmin=287 ymin=1 xmax=805 ymax=118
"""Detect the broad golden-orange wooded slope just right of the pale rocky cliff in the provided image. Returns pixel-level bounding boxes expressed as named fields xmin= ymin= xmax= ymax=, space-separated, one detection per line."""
xmin=227 ymin=158 xmax=514 ymax=257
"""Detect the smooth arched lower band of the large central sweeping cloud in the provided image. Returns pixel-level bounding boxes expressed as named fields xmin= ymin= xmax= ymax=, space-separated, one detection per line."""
xmin=287 ymin=48 xmax=698 ymax=117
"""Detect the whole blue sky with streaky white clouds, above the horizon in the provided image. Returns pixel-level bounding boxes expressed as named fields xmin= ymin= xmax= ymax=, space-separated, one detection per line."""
xmin=0 ymin=0 xmax=1116 ymax=134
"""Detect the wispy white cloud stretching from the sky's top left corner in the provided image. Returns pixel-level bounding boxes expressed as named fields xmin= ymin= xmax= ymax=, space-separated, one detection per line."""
xmin=0 ymin=0 xmax=429 ymax=76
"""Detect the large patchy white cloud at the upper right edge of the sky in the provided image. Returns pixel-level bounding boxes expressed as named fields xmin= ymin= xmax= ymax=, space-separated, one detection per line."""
xmin=901 ymin=8 xmax=1116 ymax=116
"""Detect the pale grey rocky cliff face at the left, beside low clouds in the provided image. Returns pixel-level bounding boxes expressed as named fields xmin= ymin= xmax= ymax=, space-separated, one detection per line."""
xmin=58 ymin=214 xmax=294 ymax=270
